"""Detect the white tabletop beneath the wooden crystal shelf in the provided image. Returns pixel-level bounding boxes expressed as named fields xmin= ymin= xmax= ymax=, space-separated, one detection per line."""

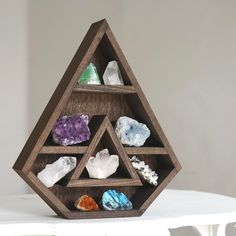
xmin=0 ymin=190 xmax=236 ymax=236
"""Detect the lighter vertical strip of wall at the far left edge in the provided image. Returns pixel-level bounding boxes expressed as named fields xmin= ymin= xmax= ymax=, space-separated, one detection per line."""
xmin=0 ymin=0 xmax=28 ymax=195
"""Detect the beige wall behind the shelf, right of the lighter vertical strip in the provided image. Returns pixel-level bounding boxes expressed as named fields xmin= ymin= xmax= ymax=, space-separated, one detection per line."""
xmin=29 ymin=0 xmax=236 ymax=196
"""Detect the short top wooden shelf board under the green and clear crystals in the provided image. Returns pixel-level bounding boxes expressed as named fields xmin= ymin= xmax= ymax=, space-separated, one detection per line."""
xmin=73 ymin=84 xmax=136 ymax=94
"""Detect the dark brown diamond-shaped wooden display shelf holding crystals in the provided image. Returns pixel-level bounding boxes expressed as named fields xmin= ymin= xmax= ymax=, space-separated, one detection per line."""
xmin=13 ymin=20 xmax=181 ymax=219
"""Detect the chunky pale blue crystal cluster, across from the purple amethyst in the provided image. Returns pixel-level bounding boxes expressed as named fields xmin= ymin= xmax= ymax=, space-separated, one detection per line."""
xmin=115 ymin=116 xmax=150 ymax=147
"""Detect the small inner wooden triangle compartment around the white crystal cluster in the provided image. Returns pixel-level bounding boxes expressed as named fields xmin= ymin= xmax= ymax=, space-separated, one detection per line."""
xmin=67 ymin=116 xmax=142 ymax=187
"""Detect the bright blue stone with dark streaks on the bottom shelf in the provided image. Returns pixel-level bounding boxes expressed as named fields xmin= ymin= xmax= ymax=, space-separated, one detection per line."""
xmin=101 ymin=189 xmax=133 ymax=211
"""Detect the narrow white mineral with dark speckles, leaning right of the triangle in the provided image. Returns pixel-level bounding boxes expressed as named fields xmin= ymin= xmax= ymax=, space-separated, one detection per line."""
xmin=130 ymin=156 xmax=158 ymax=186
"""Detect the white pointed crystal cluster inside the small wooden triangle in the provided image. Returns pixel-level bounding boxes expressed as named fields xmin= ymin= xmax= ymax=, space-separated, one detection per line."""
xmin=86 ymin=149 xmax=119 ymax=179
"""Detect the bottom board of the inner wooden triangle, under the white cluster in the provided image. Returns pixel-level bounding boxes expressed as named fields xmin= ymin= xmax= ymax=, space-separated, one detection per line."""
xmin=67 ymin=178 xmax=142 ymax=187
